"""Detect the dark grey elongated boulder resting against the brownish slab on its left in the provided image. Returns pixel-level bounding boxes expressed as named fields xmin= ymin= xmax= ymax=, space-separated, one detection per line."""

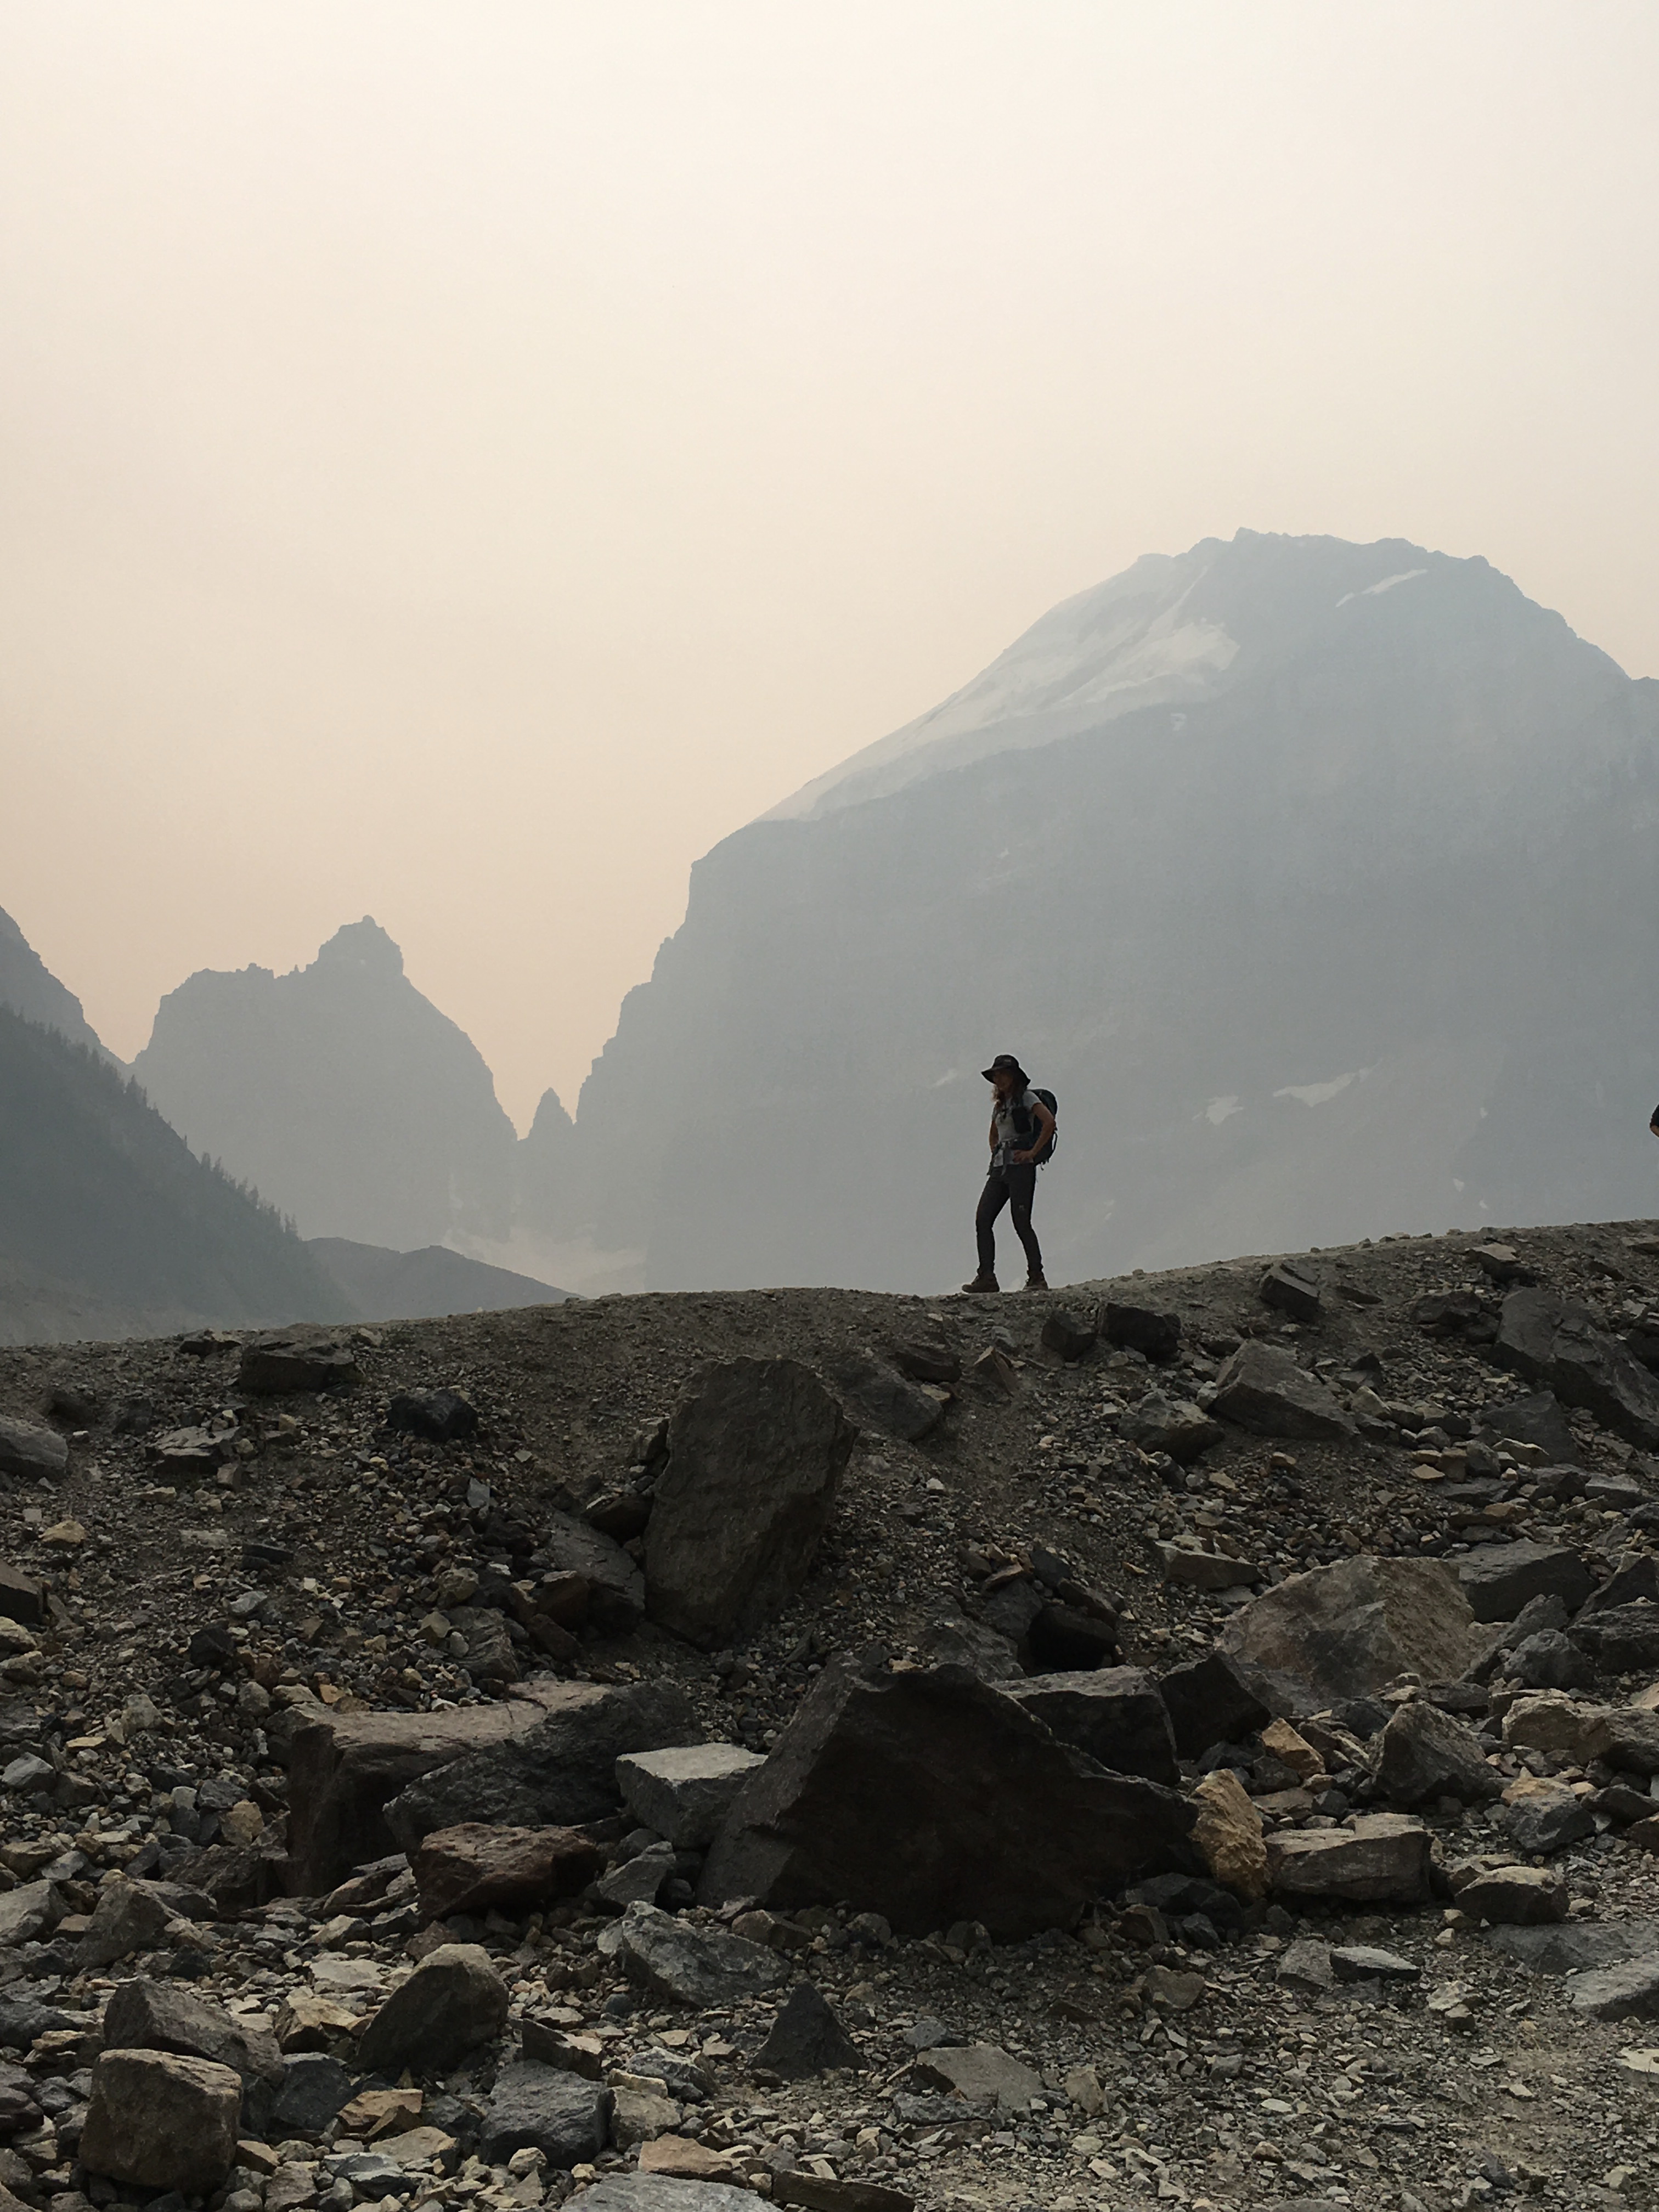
xmin=385 ymin=1681 xmax=697 ymax=1852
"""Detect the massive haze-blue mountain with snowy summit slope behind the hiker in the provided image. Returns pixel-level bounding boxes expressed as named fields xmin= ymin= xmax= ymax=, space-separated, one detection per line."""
xmin=560 ymin=531 xmax=1659 ymax=1290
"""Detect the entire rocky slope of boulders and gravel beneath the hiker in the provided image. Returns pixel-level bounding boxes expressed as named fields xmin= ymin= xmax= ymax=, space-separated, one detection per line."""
xmin=0 ymin=1223 xmax=1659 ymax=2212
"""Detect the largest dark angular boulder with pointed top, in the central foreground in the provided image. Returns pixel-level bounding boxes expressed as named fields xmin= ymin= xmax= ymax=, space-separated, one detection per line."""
xmin=701 ymin=1661 xmax=1197 ymax=1938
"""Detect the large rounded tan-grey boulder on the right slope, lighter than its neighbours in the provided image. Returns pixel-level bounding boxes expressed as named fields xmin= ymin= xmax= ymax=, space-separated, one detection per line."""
xmin=1221 ymin=1553 xmax=1484 ymax=1712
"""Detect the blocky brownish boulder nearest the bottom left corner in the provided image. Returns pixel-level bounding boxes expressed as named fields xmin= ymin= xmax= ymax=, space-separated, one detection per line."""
xmin=80 ymin=2051 xmax=241 ymax=2197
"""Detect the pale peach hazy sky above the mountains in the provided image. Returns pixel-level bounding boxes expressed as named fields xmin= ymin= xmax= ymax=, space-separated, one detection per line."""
xmin=0 ymin=0 xmax=1659 ymax=1124
